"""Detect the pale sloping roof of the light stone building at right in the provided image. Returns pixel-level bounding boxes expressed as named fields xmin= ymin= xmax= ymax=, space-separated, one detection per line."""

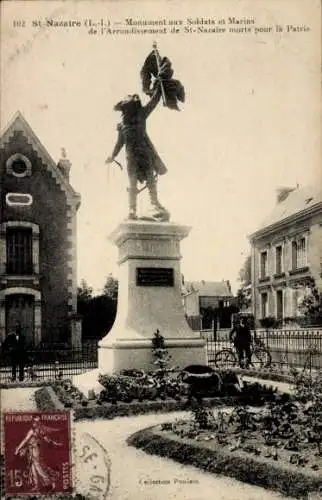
xmin=251 ymin=185 xmax=322 ymax=236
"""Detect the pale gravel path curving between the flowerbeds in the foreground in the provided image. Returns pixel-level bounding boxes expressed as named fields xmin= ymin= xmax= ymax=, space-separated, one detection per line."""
xmin=1 ymin=389 xmax=296 ymax=500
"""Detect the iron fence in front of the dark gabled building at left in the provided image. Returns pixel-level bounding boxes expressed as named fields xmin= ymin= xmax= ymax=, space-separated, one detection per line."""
xmin=0 ymin=342 xmax=98 ymax=383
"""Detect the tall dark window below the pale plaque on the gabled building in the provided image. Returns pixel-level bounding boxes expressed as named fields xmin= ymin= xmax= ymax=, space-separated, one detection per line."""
xmin=6 ymin=227 xmax=33 ymax=275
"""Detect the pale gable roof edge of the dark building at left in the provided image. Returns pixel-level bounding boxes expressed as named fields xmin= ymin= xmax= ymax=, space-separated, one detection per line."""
xmin=0 ymin=111 xmax=80 ymax=208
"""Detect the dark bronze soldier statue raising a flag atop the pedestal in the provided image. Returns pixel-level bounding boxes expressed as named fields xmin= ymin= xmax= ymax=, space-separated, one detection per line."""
xmin=106 ymin=44 xmax=185 ymax=221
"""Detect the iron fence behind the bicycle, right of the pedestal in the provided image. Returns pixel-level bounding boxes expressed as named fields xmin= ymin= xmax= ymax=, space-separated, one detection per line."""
xmin=201 ymin=328 xmax=322 ymax=370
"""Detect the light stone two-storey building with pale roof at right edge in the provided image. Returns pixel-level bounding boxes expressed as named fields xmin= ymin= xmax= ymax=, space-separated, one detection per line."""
xmin=250 ymin=186 xmax=322 ymax=320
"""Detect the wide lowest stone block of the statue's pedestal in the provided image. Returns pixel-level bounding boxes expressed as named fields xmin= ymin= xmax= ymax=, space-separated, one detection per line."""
xmin=98 ymin=338 xmax=206 ymax=373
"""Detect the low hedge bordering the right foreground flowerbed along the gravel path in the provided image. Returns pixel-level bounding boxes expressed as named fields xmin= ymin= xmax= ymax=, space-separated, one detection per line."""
xmin=127 ymin=427 xmax=322 ymax=499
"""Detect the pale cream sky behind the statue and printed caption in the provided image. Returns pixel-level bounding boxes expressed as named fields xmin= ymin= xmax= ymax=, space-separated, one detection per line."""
xmin=0 ymin=0 xmax=321 ymax=292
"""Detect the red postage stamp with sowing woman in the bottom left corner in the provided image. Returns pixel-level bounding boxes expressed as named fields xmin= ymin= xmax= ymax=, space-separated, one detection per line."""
xmin=3 ymin=411 xmax=73 ymax=495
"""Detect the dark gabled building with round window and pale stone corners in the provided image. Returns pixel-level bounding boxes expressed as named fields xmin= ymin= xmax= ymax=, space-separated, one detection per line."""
xmin=0 ymin=113 xmax=81 ymax=345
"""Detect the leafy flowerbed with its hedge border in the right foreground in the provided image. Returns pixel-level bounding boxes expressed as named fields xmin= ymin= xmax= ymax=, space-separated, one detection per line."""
xmin=128 ymin=376 xmax=322 ymax=498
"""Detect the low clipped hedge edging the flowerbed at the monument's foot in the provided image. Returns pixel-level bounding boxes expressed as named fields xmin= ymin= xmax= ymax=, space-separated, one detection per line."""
xmin=35 ymin=387 xmax=272 ymax=420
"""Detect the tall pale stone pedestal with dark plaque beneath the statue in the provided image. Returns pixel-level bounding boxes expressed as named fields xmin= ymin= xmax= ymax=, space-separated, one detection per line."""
xmin=98 ymin=220 xmax=206 ymax=373
